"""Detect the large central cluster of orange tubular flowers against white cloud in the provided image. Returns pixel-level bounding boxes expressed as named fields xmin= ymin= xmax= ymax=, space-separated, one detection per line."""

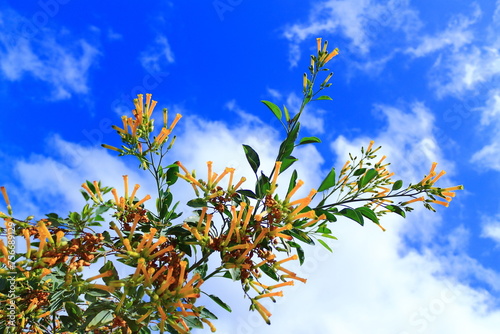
xmin=177 ymin=161 xmax=325 ymax=323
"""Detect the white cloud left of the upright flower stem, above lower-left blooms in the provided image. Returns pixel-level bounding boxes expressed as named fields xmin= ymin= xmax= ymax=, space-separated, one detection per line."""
xmin=14 ymin=136 xmax=154 ymax=215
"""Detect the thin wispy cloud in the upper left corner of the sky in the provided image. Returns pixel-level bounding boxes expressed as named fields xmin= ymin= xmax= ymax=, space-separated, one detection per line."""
xmin=0 ymin=11 xmax=99 ymax=99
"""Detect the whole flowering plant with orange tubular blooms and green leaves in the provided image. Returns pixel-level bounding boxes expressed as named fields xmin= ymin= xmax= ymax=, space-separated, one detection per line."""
xmin=0 ymin=39 xmax=463 ymax=334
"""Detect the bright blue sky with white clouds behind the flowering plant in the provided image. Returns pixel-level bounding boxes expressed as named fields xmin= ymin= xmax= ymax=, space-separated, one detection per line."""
xmin=0 ymin=0 xmax=500 ymax=334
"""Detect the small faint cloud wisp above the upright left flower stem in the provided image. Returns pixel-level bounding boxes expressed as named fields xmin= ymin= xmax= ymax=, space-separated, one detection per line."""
xmin=139 ymin=36 xmax=175 ymax=72
